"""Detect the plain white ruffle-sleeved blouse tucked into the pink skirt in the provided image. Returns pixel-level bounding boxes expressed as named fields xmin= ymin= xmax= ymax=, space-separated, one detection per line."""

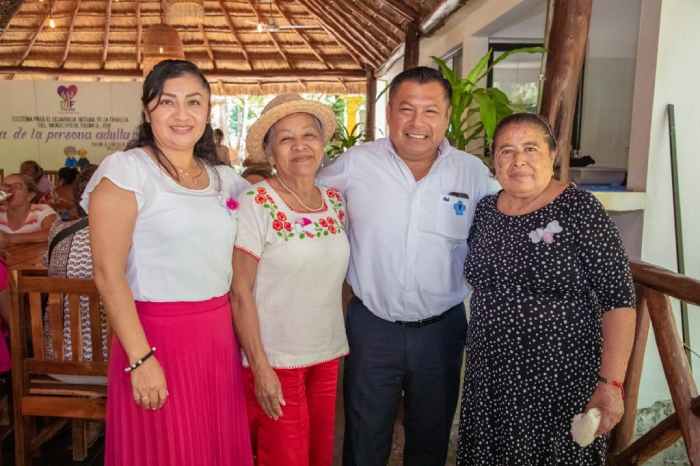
xmin=81 ymin=149 xmax=249 ymax=302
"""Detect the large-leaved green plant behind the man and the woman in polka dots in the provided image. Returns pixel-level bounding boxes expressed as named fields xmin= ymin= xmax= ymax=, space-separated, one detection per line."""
xmin=432 ymin=47 xmax=545 ymax=162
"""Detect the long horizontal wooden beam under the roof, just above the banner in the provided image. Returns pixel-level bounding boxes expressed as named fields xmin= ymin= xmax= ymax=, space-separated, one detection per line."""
xmin=0 ymin=66 xmax=365 ymax=80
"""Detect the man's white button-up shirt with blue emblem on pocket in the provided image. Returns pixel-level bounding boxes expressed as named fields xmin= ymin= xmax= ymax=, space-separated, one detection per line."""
xmin=319 ymin=139 xmax=498 ymax=321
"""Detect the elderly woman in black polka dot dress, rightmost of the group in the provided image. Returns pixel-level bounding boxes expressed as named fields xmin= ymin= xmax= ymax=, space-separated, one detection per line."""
xmin=458 ymin=113 xmax=635 ymax=466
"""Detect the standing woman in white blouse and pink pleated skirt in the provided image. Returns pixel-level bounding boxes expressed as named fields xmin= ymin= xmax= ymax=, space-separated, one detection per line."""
xmin=83 ymin=60 xmax=252 ymax=466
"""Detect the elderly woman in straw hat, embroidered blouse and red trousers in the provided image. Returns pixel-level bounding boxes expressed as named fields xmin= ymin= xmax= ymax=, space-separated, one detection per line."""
xmin=233 ymin=94 xmax=349 ymax=466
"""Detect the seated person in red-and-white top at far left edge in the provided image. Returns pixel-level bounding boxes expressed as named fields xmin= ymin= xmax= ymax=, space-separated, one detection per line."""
xmin=0 ymin=173 xmax=56 ymax=245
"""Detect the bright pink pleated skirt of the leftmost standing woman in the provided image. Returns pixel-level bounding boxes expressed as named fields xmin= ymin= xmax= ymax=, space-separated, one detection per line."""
xmin=105 ymin=295 xmax=253 ymax=466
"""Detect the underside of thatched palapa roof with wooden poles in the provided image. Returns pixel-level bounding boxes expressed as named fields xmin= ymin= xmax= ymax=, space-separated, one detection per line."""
xmin=0 ymin=0 xmax=444 ymax=94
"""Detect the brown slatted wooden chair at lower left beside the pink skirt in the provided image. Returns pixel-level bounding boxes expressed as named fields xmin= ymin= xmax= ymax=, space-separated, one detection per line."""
xmin=10 ymin=270 xmax=107 ymax=466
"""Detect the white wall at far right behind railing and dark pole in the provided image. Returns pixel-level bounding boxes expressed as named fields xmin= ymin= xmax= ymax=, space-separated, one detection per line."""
xmin=631 ymin=0 xmax=700 ymax=405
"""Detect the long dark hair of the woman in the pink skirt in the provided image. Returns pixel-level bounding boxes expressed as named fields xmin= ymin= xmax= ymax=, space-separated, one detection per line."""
xmin=126 ymin=60 xmax=223 ymax=179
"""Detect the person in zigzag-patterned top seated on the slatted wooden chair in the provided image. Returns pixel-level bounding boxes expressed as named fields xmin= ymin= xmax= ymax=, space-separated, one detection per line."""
xmin=44 ymin=166 xmax=107 ymax=360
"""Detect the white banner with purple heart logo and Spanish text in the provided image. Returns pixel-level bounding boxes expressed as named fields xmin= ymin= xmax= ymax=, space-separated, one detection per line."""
xmin=0 ymin=80 xmax=141 ymax=175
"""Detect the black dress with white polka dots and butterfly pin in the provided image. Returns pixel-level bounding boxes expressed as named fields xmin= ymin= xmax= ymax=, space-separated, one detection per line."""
xmin=457 ymin=186 xmax=635 ymax=466
